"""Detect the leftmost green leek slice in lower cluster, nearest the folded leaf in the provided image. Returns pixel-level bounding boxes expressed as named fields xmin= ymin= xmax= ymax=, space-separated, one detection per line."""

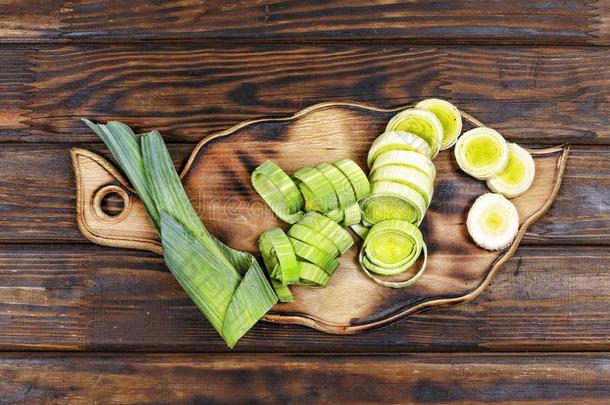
xmin=258 ymin=228 xmax=300 ymax=285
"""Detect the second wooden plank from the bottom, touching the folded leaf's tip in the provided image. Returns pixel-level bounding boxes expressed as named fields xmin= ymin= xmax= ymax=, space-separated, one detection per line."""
xmin=0 ymin=245 xmax=610 ymax=353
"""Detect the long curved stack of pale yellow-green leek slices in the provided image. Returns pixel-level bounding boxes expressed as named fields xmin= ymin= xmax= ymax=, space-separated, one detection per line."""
xmin=352 ymin=99 xmax=462 ymax=288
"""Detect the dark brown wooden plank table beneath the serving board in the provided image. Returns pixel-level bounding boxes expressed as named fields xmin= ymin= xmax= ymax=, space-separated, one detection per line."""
xmin=0 ymin=0 xmax=610 ymax=404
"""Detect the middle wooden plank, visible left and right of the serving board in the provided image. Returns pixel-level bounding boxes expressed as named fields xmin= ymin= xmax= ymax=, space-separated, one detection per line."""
xmin=0 ymin=144 xmax=610 ymax=244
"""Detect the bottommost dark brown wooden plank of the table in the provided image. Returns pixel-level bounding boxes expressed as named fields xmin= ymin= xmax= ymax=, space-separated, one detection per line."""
xmin=0 ymin=353 xmax=610 ymax=404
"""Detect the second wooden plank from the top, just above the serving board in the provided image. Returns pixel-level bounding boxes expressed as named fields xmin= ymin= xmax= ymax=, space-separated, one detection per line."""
xmin=0 ymin=43 xmax=610 ymax=145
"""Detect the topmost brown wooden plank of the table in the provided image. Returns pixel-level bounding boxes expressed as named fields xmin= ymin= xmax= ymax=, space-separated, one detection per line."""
xmin=0 ymin=0 xmax=610 ymax=44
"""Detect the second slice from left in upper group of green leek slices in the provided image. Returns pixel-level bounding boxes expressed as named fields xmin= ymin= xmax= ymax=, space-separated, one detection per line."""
xmin=292 ymin=167 xmax=339 ymax=212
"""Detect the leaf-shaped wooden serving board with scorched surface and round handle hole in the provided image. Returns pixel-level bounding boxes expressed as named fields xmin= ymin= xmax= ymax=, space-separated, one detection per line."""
xmin=72 ymin=103 xmax=569 ymax=333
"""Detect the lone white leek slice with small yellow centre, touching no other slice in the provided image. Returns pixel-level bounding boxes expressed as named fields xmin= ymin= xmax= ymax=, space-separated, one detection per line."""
xmin=466 ymin=193 xmax=519 ymax=250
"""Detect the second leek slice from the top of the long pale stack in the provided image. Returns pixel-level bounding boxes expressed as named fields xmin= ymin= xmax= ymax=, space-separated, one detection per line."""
xmin=386 ymin=108 xmax=443 ymax=159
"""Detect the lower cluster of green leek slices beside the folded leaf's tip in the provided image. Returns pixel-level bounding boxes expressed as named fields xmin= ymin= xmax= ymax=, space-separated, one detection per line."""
xmin=258 ymin=211 xmax=354 ymax=302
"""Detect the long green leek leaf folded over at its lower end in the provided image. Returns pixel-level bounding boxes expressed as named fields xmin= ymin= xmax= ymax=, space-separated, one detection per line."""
xmin=85 ymin=120 xmax=277 ymax=348
